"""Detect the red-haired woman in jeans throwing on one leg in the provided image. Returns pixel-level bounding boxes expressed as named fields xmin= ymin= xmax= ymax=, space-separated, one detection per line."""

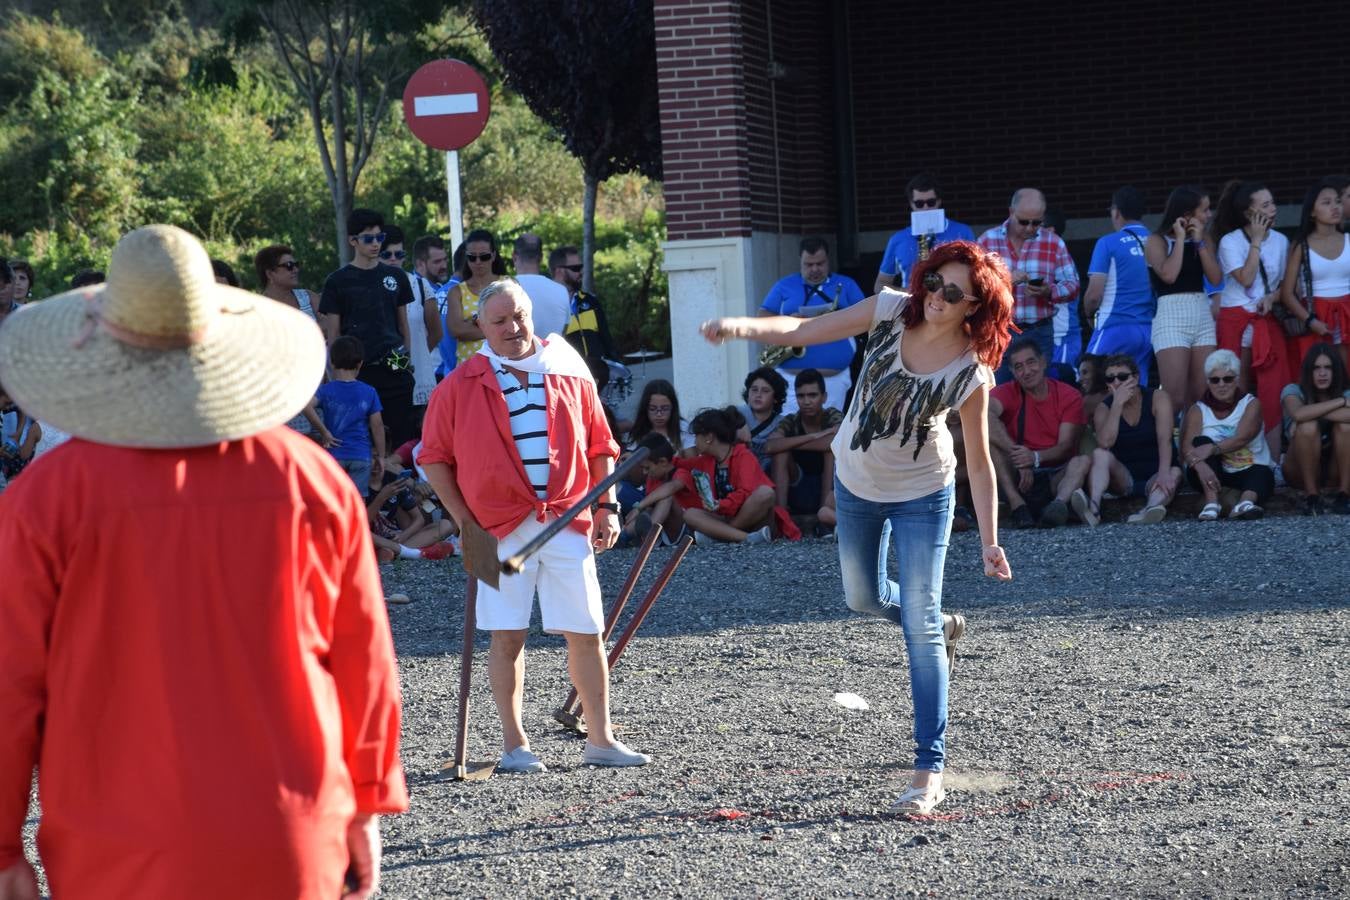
xmin=702 ymin=240 xmax=1013 ymax=814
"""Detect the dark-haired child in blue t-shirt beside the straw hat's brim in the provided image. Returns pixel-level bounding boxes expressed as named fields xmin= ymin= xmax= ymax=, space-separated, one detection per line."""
xmin=305 ymin=335 xmax=385 ymax=497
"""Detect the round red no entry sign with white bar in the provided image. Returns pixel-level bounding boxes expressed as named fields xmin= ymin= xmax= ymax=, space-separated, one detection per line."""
xmin=404 ymin=59 xmax=490 ymax=150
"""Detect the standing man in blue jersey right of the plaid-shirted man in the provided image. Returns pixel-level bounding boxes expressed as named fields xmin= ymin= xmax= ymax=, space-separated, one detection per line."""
xmin=1083 ymin=188 xmax=1154 ymax=385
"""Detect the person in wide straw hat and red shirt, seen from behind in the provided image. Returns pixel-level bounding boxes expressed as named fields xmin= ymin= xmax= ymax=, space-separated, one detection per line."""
xmin=0 ymin=225 xmax=408 ymax=900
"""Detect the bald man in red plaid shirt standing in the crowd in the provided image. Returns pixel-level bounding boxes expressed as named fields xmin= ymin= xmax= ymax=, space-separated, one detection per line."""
xmin=979 ymin=188 xmax=1079 ymax=385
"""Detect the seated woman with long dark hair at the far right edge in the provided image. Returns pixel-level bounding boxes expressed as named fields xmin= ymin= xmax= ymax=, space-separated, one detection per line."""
xmin=1280 ymin=344 xmax=1350 ymax=515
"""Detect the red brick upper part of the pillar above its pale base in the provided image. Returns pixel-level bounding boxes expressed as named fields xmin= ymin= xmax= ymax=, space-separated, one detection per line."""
xmin=655 ymin=0 xmax=751 ymax=240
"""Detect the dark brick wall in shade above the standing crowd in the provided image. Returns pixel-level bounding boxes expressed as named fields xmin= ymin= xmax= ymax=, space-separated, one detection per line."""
xmin=849 ymin=0 xmax=1350 ymax=231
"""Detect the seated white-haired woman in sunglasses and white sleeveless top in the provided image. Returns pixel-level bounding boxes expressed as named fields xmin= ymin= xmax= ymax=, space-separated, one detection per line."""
xmin=1181 ymin=349 xmax=1278 ymax=522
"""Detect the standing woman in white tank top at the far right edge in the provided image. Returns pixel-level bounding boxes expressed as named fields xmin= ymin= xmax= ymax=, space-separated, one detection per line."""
xmin=1280 ymin=179 xmax=1350 ymax=381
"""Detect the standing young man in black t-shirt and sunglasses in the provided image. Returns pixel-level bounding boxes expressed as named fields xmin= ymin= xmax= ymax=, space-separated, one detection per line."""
xmin=319 ymin=209 xmax=414 ymax=447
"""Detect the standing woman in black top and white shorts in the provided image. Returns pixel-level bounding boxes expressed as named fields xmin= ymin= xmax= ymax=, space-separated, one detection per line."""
xmin=1143 ymin=186 xmax=1223 ymax=412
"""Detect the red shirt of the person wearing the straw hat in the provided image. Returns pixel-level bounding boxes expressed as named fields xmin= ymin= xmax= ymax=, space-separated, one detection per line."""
xmin=0 ymin=428 xmax=408 ymax=900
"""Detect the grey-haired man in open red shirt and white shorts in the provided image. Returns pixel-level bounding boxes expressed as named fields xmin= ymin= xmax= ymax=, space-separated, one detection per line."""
xmin=417 ymin=278 xmax=649 ymax=773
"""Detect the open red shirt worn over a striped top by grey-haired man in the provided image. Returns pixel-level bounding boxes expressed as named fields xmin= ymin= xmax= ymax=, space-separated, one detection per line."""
xmin=417 ymin=354 xmax=618 ymax=537
